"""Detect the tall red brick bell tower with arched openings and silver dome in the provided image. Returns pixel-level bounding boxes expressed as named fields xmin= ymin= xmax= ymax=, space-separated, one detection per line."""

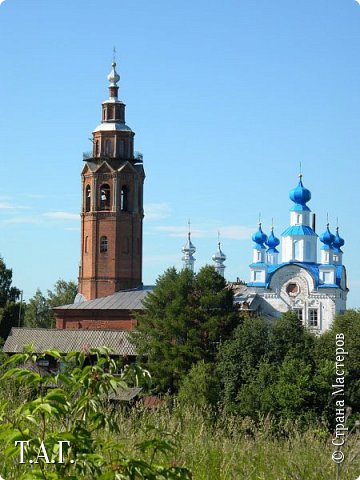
xmin=79 ymin=60 xmax=145 ymax=300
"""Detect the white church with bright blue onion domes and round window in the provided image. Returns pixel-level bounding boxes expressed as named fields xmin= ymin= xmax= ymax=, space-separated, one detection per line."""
xmin=235 ymin=175 xmax=348 ymax=333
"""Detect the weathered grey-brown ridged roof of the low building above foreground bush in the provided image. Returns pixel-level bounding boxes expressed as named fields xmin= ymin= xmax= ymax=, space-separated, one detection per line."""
xmin=3 ymin=327 xmax=136 ymax=356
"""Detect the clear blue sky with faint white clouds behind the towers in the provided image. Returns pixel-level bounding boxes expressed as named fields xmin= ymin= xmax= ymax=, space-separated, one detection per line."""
xmin=0 ymin=0 xmax=360 ymax=307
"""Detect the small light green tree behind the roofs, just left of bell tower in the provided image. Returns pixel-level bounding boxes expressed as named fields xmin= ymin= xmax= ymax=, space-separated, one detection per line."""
xmin=24 ymin=279 xmax=77 ymax=328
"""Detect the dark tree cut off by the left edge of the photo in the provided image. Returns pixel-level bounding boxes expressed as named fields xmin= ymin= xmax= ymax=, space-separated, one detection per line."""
xmin=0 ymin=257 xmax=21 ymax=340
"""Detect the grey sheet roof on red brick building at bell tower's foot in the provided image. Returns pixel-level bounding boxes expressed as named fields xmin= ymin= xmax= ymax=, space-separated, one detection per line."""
xmin=53 ymin=286 xmax=154 ymax=311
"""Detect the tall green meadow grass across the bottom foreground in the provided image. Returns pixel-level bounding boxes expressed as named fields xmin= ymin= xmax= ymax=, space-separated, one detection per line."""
xmin=106 ymin=408 xmax=360 ymax=480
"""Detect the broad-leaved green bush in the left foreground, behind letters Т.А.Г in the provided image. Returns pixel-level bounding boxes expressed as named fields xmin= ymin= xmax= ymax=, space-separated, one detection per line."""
xmin=0 ymin=348 xmax=192 ymax=480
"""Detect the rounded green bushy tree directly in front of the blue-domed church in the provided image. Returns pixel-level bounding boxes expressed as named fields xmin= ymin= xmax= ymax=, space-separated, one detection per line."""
xmin=217 ymin=313 xmax=320 ymax=419
